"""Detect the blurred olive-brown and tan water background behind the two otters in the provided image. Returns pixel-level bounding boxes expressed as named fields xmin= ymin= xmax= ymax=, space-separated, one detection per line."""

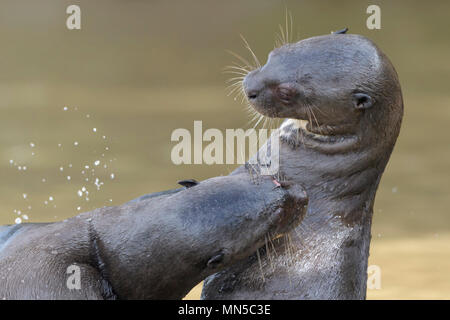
xmin=0 ymin=0 xmax=450 ymax=299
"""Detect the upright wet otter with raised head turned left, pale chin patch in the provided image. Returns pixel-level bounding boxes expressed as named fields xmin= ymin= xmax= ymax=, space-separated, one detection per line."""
xmin=202 ymin=32 xmax=403 ymax=299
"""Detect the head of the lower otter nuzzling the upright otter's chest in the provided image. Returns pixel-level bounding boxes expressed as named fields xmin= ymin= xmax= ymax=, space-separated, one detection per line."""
xmin=201 ymin=180 xmax=308 ymax=274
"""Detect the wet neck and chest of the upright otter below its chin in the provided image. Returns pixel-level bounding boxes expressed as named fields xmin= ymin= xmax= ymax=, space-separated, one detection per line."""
xmin=268 ymin=120 xmax=388 ymax=299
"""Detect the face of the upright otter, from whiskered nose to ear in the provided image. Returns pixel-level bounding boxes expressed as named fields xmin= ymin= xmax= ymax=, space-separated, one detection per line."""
xmin=243 ymin=34 xmax=399 ymax=140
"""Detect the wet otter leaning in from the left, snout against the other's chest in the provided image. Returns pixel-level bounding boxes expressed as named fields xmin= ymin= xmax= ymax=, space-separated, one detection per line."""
xmin=0 ymin=173 xmax=307 ymax=299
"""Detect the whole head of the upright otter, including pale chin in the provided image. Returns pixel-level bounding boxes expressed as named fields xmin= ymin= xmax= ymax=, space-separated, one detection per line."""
xmin=243 ymin=34 xmax=403 ymax=153
